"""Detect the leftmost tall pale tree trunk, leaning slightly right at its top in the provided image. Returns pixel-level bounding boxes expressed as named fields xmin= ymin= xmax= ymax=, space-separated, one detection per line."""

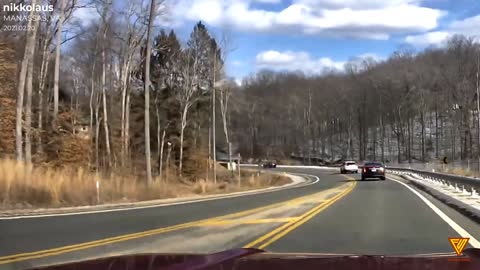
xmin=15 ymin=0 xmax=37 ymax=161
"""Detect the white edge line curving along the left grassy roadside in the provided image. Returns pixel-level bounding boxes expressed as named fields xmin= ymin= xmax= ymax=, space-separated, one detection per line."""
xmin=0 ymin=173 xmax=320 ymax=220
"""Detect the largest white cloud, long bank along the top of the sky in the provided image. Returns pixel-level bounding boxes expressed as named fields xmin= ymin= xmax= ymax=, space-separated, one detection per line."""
xmin=172 ymin=0 xmax=445 ymax=39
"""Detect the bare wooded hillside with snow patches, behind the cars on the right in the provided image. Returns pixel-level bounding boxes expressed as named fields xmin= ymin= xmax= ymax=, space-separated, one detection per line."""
xmin=232 ymin=36 xmax=480 ymax=166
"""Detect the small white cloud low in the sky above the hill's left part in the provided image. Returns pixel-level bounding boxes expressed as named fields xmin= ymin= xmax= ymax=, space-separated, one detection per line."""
xmin=256 ymin=50 xmax=345 ymax=74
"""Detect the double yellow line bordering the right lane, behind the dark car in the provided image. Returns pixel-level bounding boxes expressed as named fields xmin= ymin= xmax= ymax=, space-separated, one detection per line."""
xmin=244 ymin=177 xmax=356 ymax=249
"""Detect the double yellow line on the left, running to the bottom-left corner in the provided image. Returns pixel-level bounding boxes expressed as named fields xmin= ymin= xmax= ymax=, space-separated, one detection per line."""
xmin=0 ymin=174 xmax=329 ymax=265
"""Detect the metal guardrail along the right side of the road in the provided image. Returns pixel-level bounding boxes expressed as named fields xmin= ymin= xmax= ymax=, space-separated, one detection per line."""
xmin=386 ymin=167 xmax=480 ymax=192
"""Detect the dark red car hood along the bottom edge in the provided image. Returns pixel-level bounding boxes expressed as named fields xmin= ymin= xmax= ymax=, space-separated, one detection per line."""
xmin=28 ymin=249 xmax=480 ymax=270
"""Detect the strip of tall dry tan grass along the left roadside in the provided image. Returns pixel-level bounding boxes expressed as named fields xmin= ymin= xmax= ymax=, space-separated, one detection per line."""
xmin=0 ymin=160 xmax=290 ymax=209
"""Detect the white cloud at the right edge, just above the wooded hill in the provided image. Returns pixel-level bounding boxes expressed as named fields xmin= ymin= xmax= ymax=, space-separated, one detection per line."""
xmin=405 ymin=15 xmax=480 ymax=47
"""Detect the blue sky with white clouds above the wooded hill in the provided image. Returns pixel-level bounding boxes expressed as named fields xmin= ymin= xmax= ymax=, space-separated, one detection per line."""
xmin=163 ymin=0 xmax=480 ymax=83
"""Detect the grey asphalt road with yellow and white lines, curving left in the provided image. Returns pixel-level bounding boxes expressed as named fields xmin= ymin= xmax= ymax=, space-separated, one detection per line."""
xmin=0 ymin=168 xmax=480 ymax=269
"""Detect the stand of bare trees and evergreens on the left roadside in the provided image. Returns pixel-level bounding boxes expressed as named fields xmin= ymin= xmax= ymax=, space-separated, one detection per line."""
xmin=0 ymin=0 xmax=233 ymax=183
